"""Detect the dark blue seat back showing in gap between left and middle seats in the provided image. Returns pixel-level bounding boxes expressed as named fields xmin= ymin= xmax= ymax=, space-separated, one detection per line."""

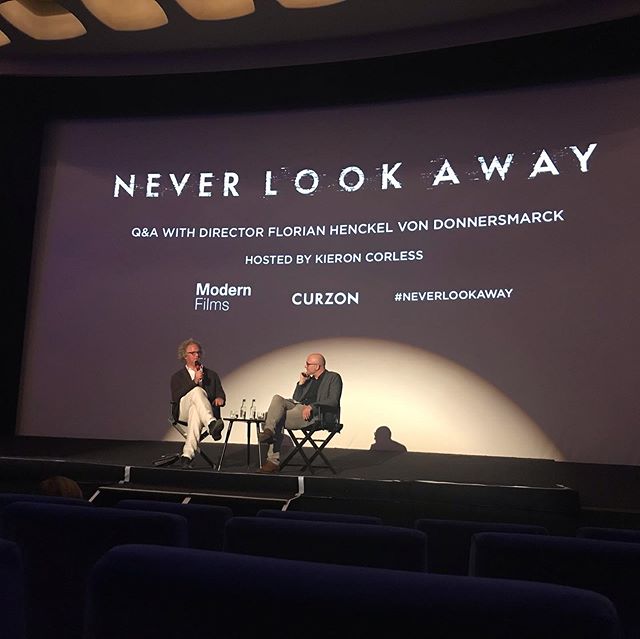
xmin=116 ymin=499 xmax=233 ymax=550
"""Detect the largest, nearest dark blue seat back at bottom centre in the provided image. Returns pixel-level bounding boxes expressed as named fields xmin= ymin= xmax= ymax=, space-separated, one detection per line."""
xmin=86 ymin=544 xmax=620 ymax=639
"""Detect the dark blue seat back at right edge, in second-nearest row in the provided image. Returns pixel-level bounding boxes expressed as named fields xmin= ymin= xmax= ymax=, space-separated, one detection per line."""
xmin=469 ymin=533 xmax=640 ymax=639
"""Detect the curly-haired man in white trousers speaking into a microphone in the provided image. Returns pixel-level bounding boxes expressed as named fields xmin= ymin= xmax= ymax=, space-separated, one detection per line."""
xmin=171 ymin=338 xmax=226 ymax=468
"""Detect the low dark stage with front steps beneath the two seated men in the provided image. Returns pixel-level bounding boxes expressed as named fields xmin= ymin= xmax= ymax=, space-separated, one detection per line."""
xmin=0 ymin=437 xmax=640 ymax=534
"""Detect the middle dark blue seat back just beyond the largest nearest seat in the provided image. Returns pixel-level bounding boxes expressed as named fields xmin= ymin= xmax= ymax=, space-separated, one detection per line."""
xmin=224 ymin=517 xmax=427 ymax=572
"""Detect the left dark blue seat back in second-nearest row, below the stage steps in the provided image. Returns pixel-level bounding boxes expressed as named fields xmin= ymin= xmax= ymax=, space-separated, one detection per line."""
xmin=4 ymin=502 xmax=188 ymax=639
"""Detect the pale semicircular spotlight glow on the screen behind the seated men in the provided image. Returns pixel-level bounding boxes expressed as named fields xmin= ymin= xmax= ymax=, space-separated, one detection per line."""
xmin=165 ymin=337 xmax=563 ymax=459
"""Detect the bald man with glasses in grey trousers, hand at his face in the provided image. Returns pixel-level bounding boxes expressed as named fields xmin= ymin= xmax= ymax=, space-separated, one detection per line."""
xmin=258 ymin=353 xmax=342 ymax=473
